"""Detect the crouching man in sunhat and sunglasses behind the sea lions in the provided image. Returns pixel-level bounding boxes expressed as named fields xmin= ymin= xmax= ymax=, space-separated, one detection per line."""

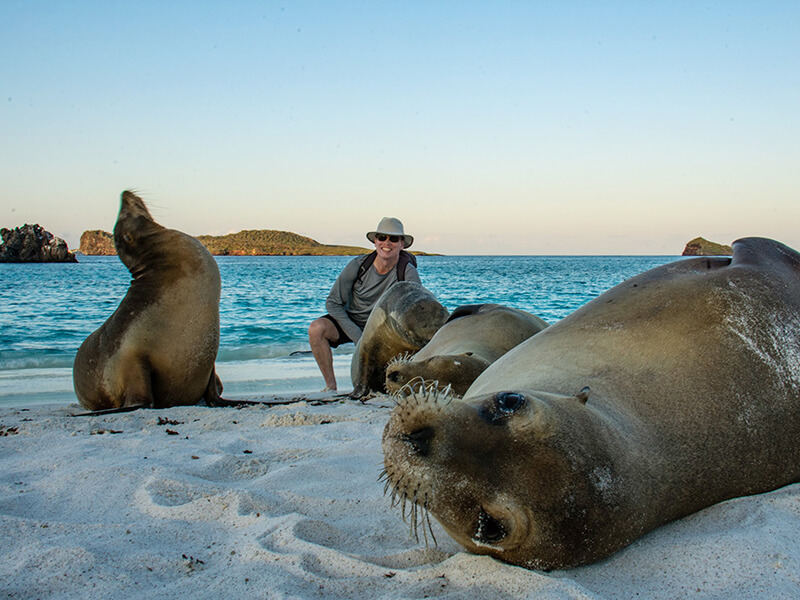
xmin=308 ymin=217 xmax=421 ymax=392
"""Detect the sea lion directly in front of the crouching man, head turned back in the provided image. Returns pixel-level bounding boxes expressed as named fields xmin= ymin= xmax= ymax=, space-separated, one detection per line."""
xmin=350 ymin=281 xmax=448 ymax=398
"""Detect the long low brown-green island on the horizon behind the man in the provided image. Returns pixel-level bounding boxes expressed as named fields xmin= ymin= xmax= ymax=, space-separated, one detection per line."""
xmin=80 ymin=229 xmax=432 ymax=256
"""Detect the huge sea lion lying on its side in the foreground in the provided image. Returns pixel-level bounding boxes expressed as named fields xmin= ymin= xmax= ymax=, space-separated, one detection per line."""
xmin=383 ymin=238 xmax=800 ymax=570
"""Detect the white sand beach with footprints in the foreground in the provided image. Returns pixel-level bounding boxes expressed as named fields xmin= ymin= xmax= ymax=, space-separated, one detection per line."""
xmin=0 ymin=394 xmax=800 ymax=600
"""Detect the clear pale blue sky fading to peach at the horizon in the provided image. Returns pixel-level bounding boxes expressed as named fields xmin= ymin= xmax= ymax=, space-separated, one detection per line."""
xmin=0 ymin=0 xmax=800 ymax=255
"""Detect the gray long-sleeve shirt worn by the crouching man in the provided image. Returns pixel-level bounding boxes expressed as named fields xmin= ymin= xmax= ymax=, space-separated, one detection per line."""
xmin=325 ymin=256 xmax=422 ymax=342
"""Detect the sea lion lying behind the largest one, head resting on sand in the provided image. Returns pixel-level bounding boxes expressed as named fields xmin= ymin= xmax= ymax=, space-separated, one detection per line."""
xmin=386 ymin=304 xmax=547 ymax=396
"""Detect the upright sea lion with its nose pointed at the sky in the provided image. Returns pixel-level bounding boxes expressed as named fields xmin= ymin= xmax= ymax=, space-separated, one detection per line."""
xmin=72 ymin=191 xmax=225 ymax=411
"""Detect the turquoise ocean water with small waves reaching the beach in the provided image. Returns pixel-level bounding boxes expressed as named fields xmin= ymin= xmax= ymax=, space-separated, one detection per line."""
xmin=0 ymin=256 xmax=679 ymax=406
